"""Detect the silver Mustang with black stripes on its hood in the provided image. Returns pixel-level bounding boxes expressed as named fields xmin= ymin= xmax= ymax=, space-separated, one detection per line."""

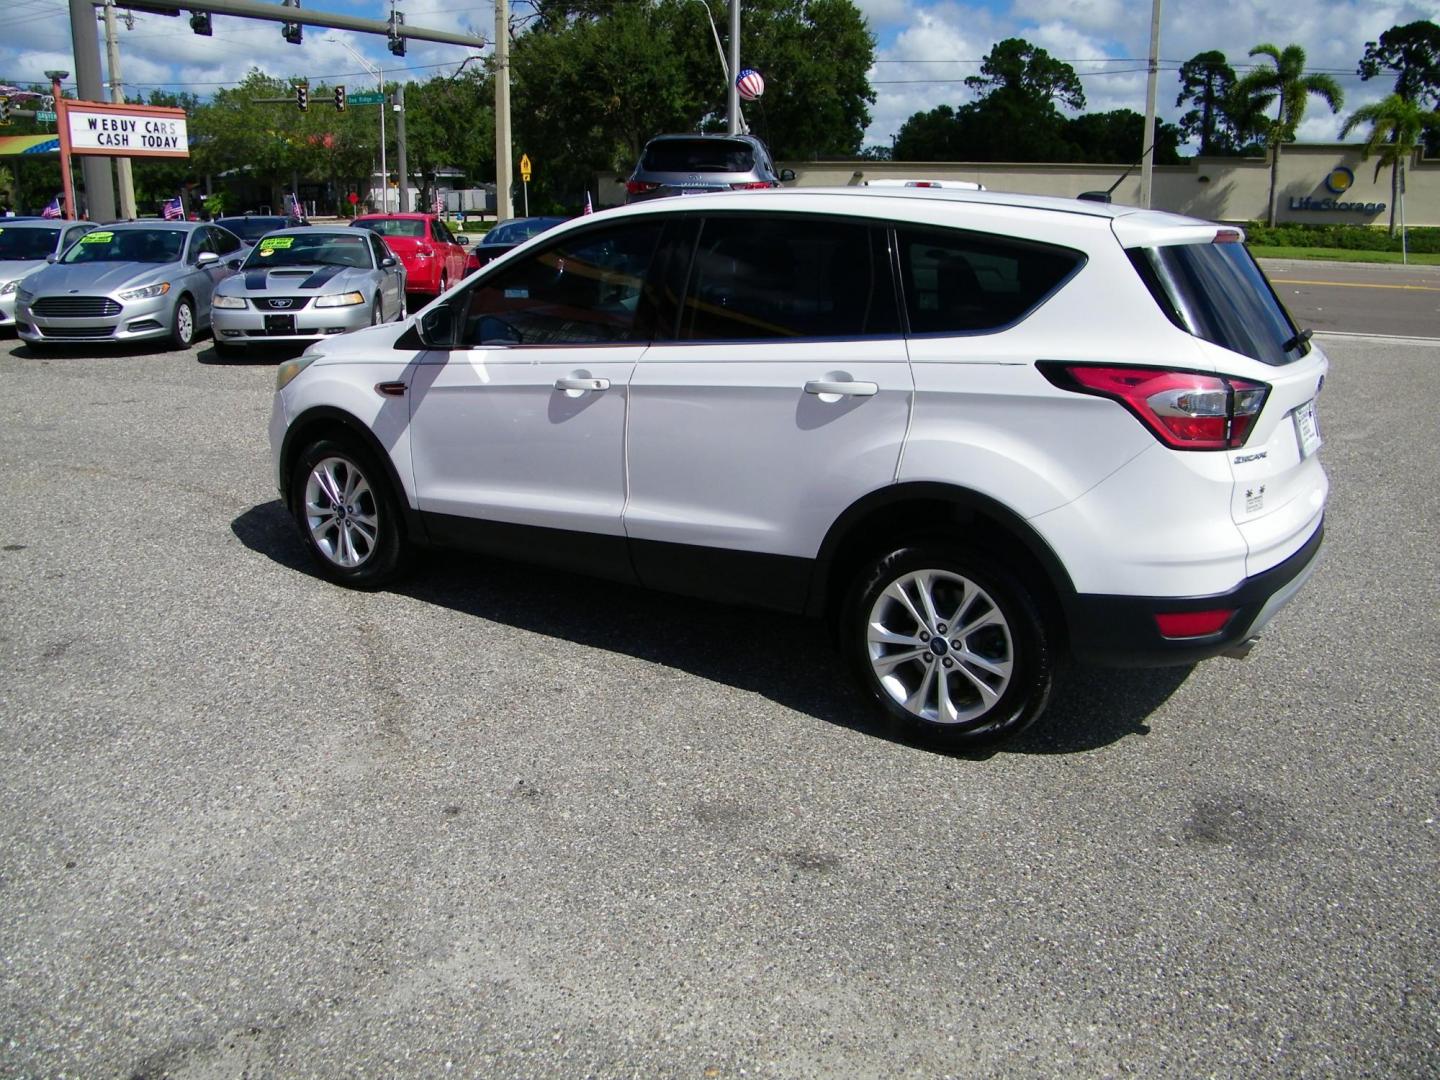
xmin=215 ymin=228 xmax=405 ymax=353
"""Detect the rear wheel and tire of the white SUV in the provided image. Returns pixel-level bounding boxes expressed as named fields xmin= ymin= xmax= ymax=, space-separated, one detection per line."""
xmin=840 ymin=541 xmax=1053 ymax=749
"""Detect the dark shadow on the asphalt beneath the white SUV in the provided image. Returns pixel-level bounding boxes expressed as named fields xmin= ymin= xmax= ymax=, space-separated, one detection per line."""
xmin=230 ymin=500 xmax=1192 ymax=760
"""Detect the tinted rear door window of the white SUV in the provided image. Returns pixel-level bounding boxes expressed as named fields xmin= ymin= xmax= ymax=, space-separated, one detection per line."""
xmin=680 ymin=215 xmax=900 ymax=341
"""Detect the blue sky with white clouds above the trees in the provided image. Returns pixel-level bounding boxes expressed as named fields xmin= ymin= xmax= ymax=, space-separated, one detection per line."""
xmin=8 ymin=0 xmax=1440 ymax=153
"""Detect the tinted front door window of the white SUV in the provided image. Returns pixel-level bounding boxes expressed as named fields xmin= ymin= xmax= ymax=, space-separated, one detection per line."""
xmin=461 ymin=225 xmax=661 ymax=346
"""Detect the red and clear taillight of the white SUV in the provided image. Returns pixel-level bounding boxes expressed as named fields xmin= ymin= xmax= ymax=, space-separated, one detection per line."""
xmin=1040 ymin=363 xmax=1270 ymax=449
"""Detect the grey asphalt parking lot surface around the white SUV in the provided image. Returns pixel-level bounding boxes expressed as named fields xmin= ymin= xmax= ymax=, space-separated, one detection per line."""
xmin=0 ymin=329 xmax=1440 ymax=1077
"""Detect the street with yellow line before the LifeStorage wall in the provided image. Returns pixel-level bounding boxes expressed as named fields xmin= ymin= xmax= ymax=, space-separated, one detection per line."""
xmin=1261 ymin=259 xmax=1440 ymax=340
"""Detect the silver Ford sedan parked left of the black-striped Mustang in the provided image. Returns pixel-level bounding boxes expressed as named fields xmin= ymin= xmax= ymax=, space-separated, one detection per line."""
xmin=14 ymin=219 xmax=246 ymax=348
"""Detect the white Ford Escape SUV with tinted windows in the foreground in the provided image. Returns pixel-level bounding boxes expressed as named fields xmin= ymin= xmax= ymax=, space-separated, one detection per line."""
xmin=271 ymin=187 xmax=1328 ymax=743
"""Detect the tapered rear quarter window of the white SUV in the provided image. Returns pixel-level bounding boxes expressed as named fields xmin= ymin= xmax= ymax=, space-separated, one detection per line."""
xmin=896 ymin=225 xmax=1084 ymax=334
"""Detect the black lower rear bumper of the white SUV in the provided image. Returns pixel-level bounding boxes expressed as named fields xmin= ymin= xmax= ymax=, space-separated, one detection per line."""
xmin=1066 ymin=523 xmax=1325 ymax=667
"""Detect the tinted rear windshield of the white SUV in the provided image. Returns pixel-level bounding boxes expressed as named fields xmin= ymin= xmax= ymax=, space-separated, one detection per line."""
xmin=1130 ymin=243 xmax=1309 ymax=366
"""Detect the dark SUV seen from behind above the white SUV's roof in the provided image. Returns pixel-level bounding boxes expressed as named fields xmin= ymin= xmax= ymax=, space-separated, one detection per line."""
xmin=625 ymin=134 xmax=795 ymax=203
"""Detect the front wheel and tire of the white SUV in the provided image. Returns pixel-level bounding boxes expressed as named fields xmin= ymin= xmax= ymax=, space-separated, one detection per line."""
xmin=289 ymin=438 xmax=408 ymax=589
